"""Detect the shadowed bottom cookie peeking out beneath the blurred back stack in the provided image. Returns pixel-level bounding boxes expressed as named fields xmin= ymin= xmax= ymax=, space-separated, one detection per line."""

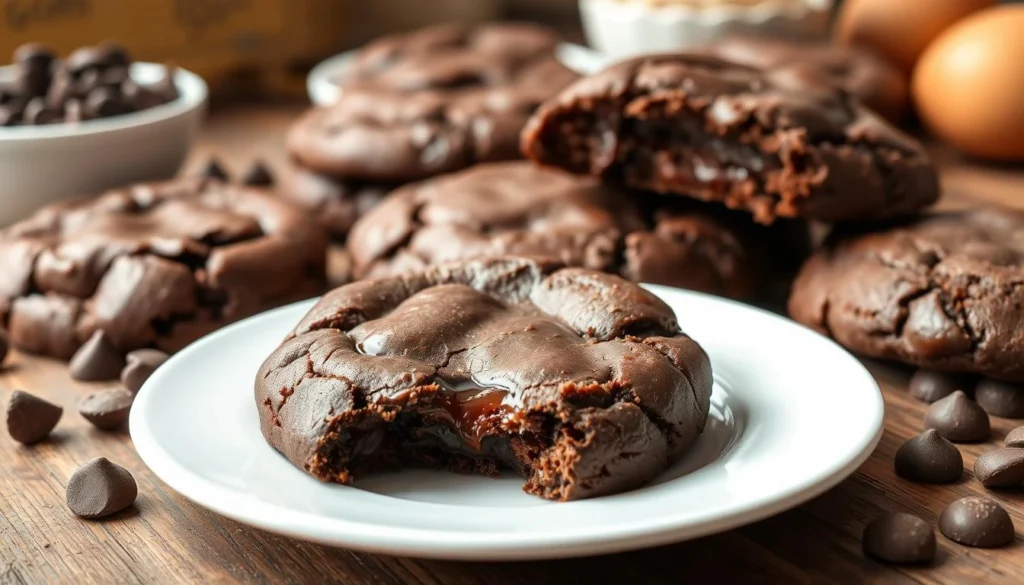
xmin=279 ymin=167 xmax=391 ymax=240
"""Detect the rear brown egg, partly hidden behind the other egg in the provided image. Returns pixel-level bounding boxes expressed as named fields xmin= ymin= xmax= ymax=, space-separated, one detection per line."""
xmin=836 ymin=0 xmax=995 ymax=73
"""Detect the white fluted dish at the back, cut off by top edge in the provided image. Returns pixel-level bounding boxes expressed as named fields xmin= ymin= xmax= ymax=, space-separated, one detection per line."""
xmin=580 ymin=0 xmax=833 ymax=57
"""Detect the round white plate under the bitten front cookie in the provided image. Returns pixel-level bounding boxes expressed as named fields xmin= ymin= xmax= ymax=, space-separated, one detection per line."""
xmin=131 ymin=286 xmax=883 ymax=560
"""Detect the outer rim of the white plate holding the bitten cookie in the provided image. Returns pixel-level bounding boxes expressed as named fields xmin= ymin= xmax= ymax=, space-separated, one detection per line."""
xmin=129 ymin=290 xmax=885 ymax=560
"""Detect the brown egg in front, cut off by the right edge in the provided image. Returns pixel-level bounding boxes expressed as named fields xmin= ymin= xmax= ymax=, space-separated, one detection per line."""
xmin=911 ymin=4 xmax=1024 ymax=161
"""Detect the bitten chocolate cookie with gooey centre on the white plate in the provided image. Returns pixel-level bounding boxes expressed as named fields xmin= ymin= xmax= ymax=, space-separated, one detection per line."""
xmin=255 ymin=257 xmax=712 ymax=500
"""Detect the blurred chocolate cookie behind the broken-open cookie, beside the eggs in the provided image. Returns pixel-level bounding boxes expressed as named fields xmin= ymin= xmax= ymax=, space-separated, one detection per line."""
xmin=707 ymin=36 xmax=907 ymax=123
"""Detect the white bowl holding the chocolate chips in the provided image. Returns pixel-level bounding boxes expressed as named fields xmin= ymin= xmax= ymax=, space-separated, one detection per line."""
xmin=0 ymin=62 xmax=207 ymax=225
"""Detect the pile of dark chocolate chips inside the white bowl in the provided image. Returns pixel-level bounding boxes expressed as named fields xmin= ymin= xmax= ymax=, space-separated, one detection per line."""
xmin=0 ymin=42 xmax=178 ymax=126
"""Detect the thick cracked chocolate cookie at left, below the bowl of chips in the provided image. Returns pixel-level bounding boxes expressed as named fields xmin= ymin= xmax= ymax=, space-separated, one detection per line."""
xmin=0 ymin=177 xmax=327 ymax=359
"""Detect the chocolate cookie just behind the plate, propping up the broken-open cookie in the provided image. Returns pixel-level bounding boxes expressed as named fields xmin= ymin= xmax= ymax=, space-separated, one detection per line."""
xmin=348 ymin=161 xmax=806 ymax=297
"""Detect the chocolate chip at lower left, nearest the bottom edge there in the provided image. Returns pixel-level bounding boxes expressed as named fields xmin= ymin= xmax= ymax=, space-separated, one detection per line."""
xmin=67 ymin=457 xmax=138 ymax=518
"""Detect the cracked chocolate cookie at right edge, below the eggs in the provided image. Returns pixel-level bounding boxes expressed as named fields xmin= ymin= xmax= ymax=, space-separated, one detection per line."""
xmin=790 ymin=206 xmax=1024 ymax=381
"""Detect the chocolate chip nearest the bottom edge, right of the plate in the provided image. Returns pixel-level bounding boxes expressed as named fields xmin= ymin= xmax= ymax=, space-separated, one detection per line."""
xmin=861 ymin=512 xmax=935 ymax=563
